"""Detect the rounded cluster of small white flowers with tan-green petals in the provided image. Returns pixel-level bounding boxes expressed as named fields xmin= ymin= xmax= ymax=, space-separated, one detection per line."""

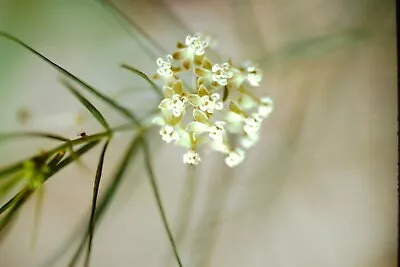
xmin=153 ymin=33 xmax=273 ymax=167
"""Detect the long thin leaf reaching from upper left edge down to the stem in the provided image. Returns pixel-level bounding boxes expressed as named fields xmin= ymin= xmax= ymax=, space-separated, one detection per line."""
xmin=0 ymin=31 xmax=139 ymax=124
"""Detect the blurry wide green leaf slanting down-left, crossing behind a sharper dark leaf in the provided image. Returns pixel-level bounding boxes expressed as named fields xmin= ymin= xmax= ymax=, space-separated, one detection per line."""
xmin=69 ymin=136 xmax=140 ymax=267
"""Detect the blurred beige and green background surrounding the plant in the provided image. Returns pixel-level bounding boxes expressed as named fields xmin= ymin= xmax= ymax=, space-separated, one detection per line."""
xmin=0 ymin=0 xmax=398 ymax=267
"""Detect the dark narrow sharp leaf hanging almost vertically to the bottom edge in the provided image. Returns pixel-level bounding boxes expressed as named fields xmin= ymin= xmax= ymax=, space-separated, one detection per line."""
xmin=85 ymin=140 xmax=109 ymax=267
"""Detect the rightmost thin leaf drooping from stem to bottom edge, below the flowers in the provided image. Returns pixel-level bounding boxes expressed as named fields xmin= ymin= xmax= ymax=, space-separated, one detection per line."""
xmin=141 ymin=138 xmax=182 ymax=267
